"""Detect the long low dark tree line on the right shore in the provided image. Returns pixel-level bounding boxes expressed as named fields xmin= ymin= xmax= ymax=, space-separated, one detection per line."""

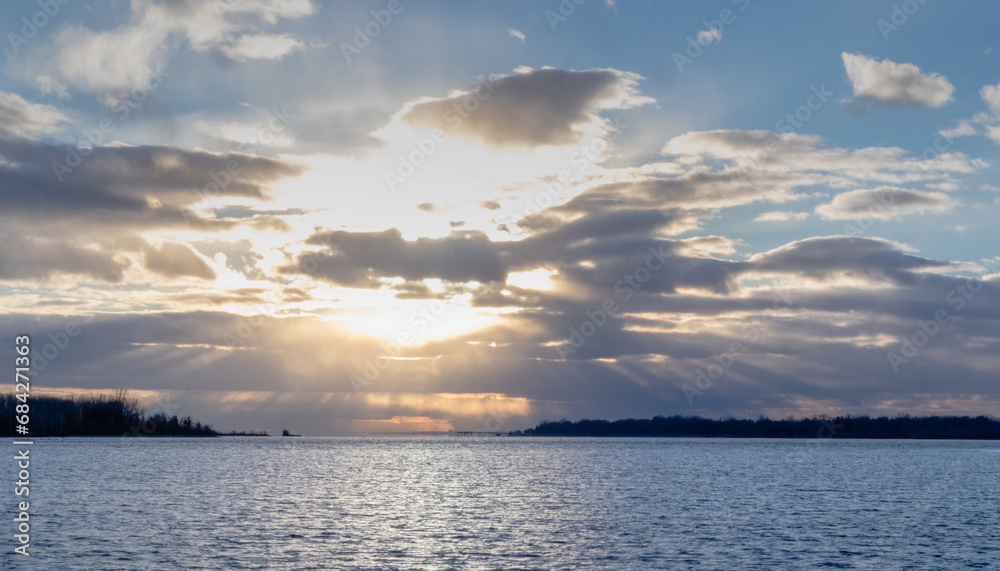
xmin=510 ymin=415 xmax=1000 ymax=439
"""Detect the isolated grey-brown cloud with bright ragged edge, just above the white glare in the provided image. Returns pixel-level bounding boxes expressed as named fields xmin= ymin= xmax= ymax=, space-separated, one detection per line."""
xmin=402 ymin=68 xmax=653 ymax=149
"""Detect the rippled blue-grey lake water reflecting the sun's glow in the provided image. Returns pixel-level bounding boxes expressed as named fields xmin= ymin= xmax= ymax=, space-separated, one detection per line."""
xmin=9 ymin=438 xmax=1000 ymax=570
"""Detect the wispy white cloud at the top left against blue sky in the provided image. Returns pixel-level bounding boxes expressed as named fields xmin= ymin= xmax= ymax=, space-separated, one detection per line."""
xmin=24 ymin=0 xmax=318 ymax=92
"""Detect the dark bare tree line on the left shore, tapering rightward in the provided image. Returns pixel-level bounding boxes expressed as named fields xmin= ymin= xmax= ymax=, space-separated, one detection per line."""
xmin=0 ymin=389 xmax=218 ymax=437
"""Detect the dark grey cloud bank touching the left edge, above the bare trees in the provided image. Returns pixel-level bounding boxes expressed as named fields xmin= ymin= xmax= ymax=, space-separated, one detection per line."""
xmin=0 ymin=138 xmax=304 ymax=281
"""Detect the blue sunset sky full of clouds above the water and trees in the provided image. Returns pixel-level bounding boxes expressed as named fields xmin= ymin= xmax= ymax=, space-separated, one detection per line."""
xmin=0 ymin=0 xmax=1000 ymax=435
